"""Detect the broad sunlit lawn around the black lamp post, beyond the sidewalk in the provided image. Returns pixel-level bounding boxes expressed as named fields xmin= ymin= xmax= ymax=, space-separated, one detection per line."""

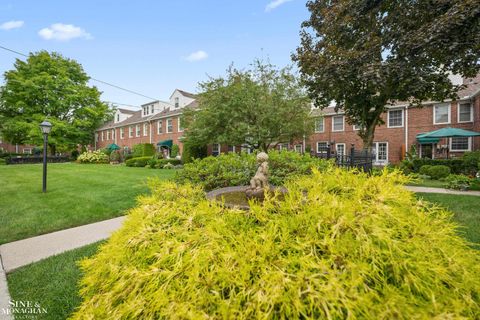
xmin=0 ymin=163 xmax=174 ymax=244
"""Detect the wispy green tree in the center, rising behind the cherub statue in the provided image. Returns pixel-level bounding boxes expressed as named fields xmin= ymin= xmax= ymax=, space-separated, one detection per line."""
xmin=184 ymin=60 xmax=313 ymax=151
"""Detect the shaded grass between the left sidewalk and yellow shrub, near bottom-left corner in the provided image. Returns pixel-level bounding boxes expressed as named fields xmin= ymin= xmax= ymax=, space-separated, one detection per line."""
xmin=7 ymin=243 xmax=100 ymax=320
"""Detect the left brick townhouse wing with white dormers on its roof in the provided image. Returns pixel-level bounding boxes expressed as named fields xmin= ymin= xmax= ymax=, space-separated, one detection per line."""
xmin=95 ymin=89 xmax=197 ymax=154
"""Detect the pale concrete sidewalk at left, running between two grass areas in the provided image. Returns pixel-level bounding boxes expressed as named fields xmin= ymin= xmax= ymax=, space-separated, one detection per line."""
xmin=0 ymin=216 xmax=125 ymax=273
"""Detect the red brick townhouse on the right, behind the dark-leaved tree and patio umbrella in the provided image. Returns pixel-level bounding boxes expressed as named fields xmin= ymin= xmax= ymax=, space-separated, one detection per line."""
xmin=310 ymin=76 xmax=480 ymax=165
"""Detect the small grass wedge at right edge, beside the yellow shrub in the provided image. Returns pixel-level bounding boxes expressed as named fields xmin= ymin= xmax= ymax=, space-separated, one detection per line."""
xmin=417 ymin=193 xmax=480 ymax=245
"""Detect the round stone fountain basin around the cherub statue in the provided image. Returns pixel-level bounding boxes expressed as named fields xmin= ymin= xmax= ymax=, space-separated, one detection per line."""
xmin=207 ymin=186 xmax=287 ymax=210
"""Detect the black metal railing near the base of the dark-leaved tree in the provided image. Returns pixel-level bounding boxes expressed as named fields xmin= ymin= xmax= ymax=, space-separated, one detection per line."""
xmin=312 ymin=144 xmax=375 ymax=172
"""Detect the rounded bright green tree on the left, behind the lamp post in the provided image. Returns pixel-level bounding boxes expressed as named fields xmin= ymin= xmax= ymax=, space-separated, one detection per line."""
xmin=0 ymin=51 xmax=111 ymax=153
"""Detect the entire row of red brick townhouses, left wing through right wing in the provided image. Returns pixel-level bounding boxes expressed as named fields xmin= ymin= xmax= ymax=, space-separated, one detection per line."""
xmin=96 ymin=76 xmax=480 ymax=165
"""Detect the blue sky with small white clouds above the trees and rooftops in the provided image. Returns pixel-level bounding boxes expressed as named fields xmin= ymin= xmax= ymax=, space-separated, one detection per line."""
xmin=0 ymin=0 xmax=308 ymax=109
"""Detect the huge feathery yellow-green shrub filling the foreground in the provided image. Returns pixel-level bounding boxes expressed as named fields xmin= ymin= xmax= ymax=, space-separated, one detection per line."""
xmin=73 ymin=169 xmax=480 ymax=319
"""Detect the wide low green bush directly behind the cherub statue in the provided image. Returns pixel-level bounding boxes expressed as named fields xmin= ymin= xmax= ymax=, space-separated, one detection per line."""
xmin=175 ymin=150 xmax=329 ymax=191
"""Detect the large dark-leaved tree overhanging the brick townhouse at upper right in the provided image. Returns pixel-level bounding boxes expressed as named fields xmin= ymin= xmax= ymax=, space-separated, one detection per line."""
xmin=293 ymin=0 xmax=480 ymax=147
